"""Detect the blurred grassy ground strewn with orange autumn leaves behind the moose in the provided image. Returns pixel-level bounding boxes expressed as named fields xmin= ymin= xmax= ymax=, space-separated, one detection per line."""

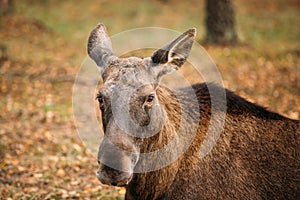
xmin=0 ymin=0 xmax=300 ymax=200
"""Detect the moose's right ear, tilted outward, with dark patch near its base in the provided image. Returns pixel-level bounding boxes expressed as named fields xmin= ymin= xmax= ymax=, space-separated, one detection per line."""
xmin=151 ymin=28 xmax=196 ymax=79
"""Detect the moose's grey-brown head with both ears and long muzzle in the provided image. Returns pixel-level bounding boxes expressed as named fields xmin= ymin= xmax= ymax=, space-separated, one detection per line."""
xmin=87 ymin=24 xmax=196 ymax=186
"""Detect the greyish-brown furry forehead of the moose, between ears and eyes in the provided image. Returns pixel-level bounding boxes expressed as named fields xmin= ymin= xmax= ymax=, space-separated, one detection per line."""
xmin=101 ymin=57 xmax=155 ymax=92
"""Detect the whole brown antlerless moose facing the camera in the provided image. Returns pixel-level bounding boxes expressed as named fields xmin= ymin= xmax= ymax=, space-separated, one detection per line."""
xmin=87 ymin=23 xmax=300 ymax=200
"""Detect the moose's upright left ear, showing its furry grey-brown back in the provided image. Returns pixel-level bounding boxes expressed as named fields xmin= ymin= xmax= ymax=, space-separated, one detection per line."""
xmin=87 ymin=23 xmax=116 ymax=74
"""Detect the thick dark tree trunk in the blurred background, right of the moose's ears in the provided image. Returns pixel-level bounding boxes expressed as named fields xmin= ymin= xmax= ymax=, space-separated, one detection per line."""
xmin=205 ymin=0 xmax=237 ymax=45
